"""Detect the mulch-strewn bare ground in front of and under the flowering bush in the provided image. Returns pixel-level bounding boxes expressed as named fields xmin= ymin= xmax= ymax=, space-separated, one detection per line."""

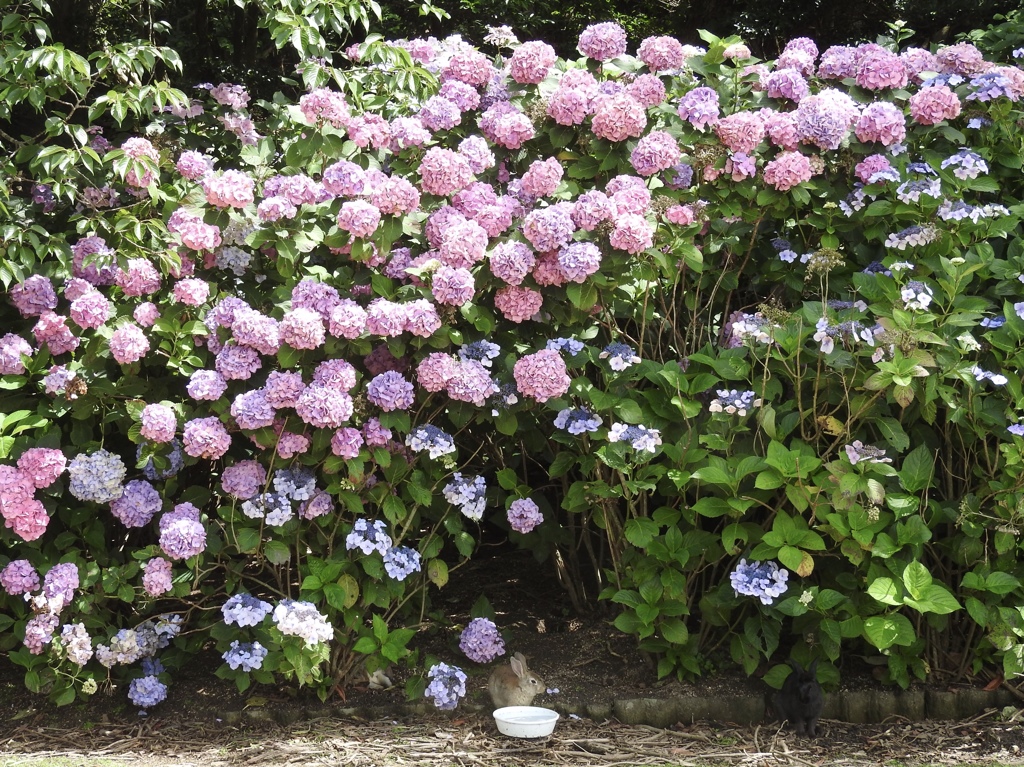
xmin=0 ymin=555 xmax=1024 ymax=767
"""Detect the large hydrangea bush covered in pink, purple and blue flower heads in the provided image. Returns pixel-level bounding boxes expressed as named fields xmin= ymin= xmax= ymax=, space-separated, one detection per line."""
xmin=6 ymin=2 xmax=1024 ymax=709
